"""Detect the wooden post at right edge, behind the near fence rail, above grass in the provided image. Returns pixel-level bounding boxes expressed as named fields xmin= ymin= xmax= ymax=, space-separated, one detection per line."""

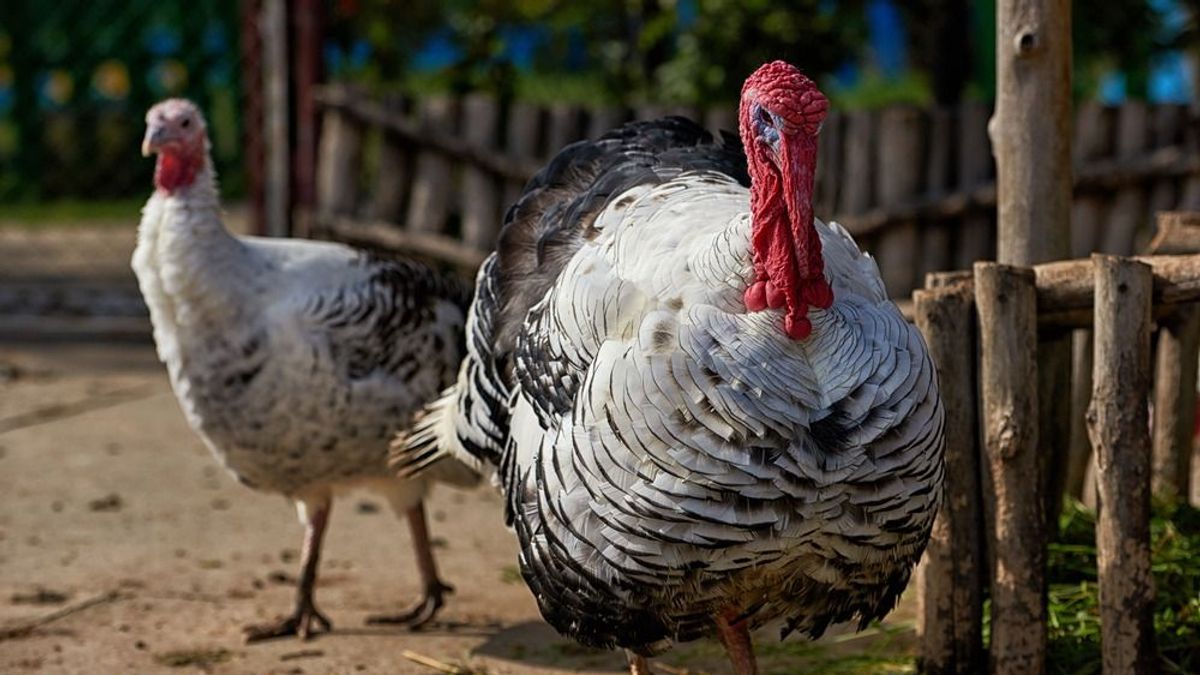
xmin=1151 ymin=305 xmax=1200 ymax=502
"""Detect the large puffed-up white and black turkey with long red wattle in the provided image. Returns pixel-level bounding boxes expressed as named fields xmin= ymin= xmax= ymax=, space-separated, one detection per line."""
xmin=394 ymin=61 xmax=943 ymax=674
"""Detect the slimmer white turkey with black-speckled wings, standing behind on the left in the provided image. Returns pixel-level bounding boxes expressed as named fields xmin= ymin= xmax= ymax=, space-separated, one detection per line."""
xmin=133 ymin=98 xmax=476 ymax=640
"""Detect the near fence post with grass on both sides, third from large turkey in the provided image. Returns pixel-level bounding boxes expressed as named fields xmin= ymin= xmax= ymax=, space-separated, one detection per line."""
xmin=1087 ymin=256 xmax=1157 ymax=675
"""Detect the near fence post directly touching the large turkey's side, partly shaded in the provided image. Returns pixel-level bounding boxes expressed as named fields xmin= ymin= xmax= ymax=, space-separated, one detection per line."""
xmin=913 ymin=275 xmax=984 ymax=675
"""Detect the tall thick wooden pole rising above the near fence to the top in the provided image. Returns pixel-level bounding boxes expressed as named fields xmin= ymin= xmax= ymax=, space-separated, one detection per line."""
xmin=988 ymin=0 xmax=1072 ymax=535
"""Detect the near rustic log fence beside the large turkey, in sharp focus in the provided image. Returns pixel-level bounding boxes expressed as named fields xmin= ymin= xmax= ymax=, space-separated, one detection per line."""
xmin=913 ymin=227 xmax=1200 ymax=675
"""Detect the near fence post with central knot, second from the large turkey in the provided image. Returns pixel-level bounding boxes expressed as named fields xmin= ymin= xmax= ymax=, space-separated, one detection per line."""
xmin=974 ymin=262 xmax=1046 ymax=675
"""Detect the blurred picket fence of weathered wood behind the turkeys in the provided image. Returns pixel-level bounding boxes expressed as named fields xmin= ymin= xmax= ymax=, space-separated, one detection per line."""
xmin=304 ymin=85 xmax=1200 ymax=298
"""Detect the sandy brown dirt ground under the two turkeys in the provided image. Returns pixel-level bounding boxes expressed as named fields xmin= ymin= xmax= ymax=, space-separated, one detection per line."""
xmin=0 ymin=341 xmax=912 ymax=675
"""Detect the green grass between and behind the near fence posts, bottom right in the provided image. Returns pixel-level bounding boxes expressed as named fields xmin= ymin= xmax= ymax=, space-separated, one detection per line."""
xmin=1048 ymin=501 xmax=1200 ymax=675
